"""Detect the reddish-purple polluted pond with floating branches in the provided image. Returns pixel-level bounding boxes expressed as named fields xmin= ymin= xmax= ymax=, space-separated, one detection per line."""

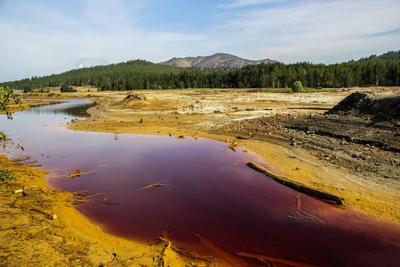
xmin=0 ymin=100 xmax=400 ymax=266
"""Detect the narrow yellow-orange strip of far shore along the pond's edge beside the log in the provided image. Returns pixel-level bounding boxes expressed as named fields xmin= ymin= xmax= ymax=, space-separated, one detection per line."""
xmin=69 ymin=121 xmax=400 ymax=225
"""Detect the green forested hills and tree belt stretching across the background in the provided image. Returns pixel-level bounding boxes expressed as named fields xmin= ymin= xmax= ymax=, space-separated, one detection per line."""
xmin=3 ymin=51 xmax=400 ymax=91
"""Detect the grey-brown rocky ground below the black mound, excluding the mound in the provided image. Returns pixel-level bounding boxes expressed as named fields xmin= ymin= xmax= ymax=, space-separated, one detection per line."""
xmin=216 ymin=114 xmax=400 ymax=190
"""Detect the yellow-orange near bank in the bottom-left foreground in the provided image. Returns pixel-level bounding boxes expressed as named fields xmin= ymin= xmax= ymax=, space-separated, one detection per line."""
xmin=0 ymin=99 xmax=228 ymax=266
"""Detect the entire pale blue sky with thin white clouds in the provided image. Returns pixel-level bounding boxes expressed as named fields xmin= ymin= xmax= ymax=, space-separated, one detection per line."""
xmin=0 ymin=0 xmax=400 ymax=81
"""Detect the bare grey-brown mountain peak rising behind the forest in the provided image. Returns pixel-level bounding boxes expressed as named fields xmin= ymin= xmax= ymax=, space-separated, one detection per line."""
xmin=159 ymin=53 xmax=278 ymax=69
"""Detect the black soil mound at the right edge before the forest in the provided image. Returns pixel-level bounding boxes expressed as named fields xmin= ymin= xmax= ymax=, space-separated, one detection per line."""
xmin=328 ymin=92 xmax=400 ymax=120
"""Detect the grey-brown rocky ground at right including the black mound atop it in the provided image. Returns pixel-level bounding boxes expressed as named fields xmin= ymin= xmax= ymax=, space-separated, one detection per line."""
xmin=219 ymin=92 xmax=400 ymax=190
